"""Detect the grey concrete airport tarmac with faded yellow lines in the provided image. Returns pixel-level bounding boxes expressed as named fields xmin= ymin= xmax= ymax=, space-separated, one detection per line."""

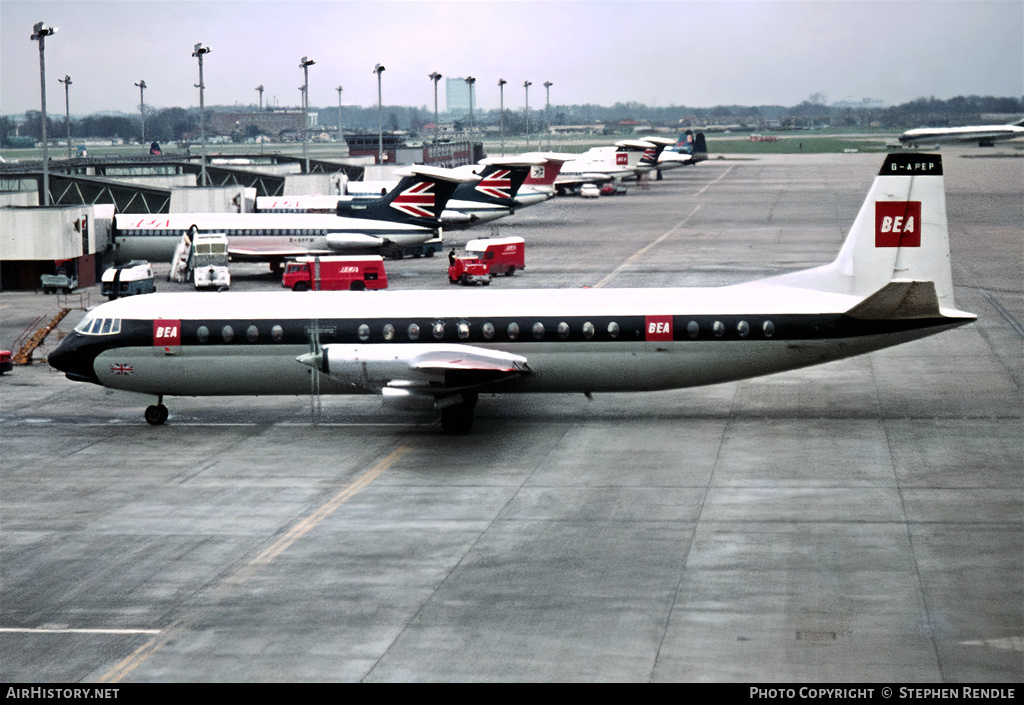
xmin=0 ymin=148 xmax=1024 ymax=683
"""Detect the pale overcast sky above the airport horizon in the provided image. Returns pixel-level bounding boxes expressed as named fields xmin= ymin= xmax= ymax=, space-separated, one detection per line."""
xmin=0 ymin=0 xmax=1024 ymax=115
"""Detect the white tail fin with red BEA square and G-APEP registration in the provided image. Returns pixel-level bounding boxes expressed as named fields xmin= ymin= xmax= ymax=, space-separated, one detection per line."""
xmin=770 ymin=154 xmax=956 ymax=309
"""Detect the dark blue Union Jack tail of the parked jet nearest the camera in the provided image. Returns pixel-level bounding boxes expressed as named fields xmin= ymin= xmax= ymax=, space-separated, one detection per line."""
xmin=338 ymin=165 xmax=478 ymax=227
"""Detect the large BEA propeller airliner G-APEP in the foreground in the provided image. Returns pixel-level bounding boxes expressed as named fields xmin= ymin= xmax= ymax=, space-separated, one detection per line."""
xmin=49 ymin=154 xmax=976 ymax=432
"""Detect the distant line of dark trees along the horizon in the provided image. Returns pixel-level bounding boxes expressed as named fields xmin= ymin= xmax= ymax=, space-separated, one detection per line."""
xmin=0 ymin=93 xmax=1024 ymax=147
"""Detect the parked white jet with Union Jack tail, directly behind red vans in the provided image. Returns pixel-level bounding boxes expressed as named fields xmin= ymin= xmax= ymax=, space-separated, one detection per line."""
xmin=111 ymin=166 xmax=478 ymax=266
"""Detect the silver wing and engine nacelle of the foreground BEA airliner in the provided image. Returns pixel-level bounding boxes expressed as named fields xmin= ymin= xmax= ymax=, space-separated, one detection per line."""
xmin=297 ymin=343 xmax=529 ymax=397
